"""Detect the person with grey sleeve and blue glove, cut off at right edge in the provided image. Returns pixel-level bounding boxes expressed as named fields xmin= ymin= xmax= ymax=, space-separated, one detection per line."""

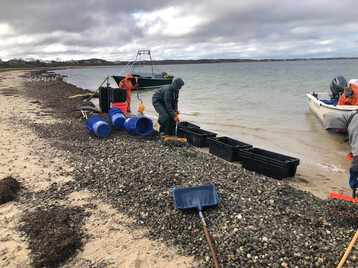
xmin=323 ymin=110 xmax=358 ymax=198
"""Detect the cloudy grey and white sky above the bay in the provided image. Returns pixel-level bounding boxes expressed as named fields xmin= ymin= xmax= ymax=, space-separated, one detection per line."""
xmin=0 ymin=0 xmax=358 ymax=61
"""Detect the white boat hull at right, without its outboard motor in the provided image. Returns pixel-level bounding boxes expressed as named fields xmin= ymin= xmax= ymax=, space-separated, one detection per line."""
xmin=306 ymin=92 xmax=358 ymax=125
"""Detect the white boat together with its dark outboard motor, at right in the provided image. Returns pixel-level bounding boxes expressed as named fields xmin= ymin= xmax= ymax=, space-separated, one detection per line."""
xmin=306 ymin=76 xmax=358 ymax=125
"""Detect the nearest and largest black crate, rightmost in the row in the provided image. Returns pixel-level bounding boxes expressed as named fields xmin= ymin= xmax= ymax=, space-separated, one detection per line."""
xmin=241 ymin=148 xmax=300 ymax=180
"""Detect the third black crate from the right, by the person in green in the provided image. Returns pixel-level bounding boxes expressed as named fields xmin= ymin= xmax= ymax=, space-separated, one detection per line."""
xmin=178 ymin=127 xmax=216 ymax=147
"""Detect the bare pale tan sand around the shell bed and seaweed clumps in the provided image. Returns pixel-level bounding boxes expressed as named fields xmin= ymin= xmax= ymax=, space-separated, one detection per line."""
xmin=0 ymin=70 xmax=351 ymax=267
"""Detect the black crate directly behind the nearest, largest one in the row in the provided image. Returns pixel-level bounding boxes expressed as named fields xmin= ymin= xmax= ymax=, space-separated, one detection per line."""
xmin=207 ymin=137 xmax=252 ymax=162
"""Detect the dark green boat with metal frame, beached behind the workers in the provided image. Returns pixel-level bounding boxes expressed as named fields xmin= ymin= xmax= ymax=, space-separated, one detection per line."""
xmin=112 ymin=50 xmax=174 ymax=89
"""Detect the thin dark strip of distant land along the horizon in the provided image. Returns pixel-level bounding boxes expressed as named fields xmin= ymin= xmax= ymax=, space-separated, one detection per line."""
xmin=0 ymin=57 xmax=358 ymax=71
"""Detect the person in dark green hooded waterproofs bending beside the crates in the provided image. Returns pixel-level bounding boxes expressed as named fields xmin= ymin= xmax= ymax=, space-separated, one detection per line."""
xmin=152 ymin=77 xmax=184 ymax=136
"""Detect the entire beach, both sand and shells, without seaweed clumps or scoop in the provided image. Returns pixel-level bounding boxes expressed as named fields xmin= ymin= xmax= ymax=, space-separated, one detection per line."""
xmin=0 ymin=71 xmax=358 ymax=267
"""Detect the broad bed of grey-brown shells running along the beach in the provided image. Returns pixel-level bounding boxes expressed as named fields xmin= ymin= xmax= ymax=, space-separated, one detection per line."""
xmin=7 ymin=70 xmax=358 ymax=267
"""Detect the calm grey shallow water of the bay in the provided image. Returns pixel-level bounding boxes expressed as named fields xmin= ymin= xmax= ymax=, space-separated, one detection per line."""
xmin=57 ymin=60 xmax=358 ymax=180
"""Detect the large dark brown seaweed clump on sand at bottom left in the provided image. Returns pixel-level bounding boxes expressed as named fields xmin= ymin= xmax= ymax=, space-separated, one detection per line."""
xmin=19 ymin=206 xmax=82 ymax=267
